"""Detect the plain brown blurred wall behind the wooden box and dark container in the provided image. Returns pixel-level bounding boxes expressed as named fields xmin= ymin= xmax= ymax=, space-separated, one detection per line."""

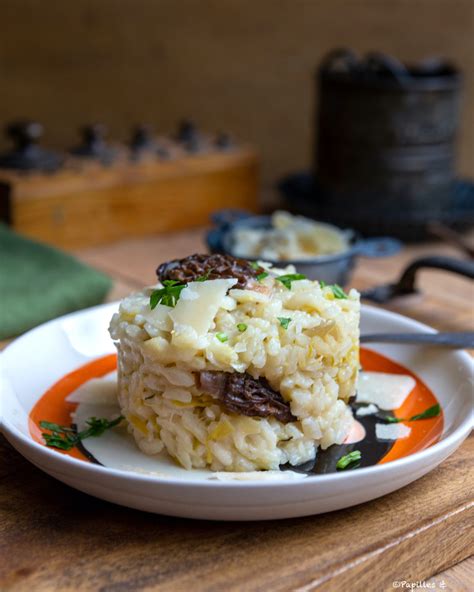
xmin=0 ymin=0 xmax=474 ymax=188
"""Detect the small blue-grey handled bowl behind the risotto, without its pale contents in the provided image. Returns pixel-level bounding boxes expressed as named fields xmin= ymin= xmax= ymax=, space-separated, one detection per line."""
xmin=206 ymin=209 xmax=402 ymax=286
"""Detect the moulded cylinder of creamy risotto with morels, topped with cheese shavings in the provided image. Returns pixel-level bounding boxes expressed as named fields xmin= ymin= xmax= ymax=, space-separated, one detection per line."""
xmin=110 ymin=255 xmax=360 ymax=471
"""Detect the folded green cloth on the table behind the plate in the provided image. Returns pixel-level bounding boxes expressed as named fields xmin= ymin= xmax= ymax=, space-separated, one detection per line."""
xmin=0 ymin=224 xmax=112 ymax=339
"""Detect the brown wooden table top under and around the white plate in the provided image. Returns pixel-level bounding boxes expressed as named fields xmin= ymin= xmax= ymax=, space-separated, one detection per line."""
xmin=0 ymin=231 xmax=474 ymax=592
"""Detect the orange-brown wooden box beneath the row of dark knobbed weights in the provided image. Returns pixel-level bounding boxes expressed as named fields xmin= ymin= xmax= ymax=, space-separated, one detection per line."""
xmin=0 ymin=146 xmax=259 ymax=248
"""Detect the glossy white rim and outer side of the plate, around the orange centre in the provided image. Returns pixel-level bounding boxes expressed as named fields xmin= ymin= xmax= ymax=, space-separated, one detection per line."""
xmin=0 ymin=304 xmax=473 ymax=520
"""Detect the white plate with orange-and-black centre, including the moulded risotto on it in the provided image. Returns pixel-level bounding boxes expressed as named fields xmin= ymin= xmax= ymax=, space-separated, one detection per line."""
xmin=1 ymin=255 xmax=472 ymax=519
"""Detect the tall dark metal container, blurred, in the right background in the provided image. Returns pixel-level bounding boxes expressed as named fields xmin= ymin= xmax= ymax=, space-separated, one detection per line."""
xmin=314 ymin=50 xmax=461 ymax=215
